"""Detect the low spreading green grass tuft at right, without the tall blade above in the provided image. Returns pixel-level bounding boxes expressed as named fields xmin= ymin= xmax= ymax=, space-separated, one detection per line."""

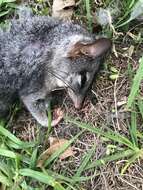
xmin=67 ymin=111 xmax=143 ymax=174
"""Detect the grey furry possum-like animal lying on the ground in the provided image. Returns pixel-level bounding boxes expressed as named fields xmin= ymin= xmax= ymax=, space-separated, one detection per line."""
xmin=0 ymin=16 xmax=111 ymax=126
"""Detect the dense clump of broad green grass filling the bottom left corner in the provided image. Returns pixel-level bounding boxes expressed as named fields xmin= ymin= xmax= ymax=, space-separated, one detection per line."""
xmin=0 ymin=124 xmax=83 ymax=190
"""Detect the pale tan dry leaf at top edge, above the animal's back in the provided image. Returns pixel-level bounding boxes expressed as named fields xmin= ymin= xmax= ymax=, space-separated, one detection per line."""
xmin=52 ymin=0 xmax=76 ymax=20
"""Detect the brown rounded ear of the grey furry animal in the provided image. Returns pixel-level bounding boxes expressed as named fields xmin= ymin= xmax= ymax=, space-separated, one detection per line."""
xmin=68 ymin=38 xmax=112 ymax=58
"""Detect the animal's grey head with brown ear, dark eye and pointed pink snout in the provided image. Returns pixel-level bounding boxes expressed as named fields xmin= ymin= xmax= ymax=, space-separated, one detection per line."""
xmin=50 ymin=38 xmax=111 ymax=108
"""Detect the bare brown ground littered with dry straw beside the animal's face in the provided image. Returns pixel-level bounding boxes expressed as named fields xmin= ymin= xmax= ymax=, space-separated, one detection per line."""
xmin=0 ymin=0 xmax=143 ymax=190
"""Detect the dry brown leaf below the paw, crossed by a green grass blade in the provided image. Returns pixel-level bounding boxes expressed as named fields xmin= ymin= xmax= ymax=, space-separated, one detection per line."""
xmin=37 ymin=137 xmax=75 ymax=167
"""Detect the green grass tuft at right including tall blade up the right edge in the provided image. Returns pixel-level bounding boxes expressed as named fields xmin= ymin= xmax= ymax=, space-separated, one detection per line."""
xmin=67 ymin=54 xmax=143 ymax=177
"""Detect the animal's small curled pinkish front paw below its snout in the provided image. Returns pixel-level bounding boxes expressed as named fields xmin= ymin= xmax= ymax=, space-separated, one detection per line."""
xmin=51 ymin=108 xmax=64 ymax=127
